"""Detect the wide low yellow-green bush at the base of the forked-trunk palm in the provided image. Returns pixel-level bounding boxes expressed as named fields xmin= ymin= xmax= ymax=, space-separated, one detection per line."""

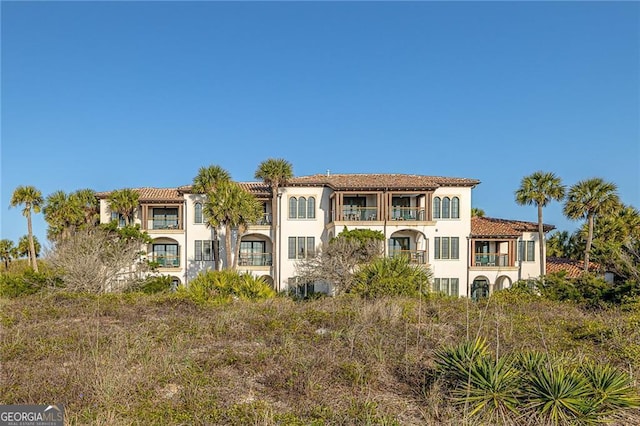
xmin=178 ymin=270 xmax=276 ymax=303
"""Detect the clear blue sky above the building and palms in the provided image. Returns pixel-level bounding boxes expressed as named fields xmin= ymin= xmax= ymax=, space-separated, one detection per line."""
xmin=0 ymin=1 xmax=640 ymax=248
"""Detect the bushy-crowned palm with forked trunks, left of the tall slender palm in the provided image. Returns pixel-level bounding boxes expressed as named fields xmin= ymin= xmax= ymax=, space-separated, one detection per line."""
xmin=202 ymin=181 xmax=262 ymax=269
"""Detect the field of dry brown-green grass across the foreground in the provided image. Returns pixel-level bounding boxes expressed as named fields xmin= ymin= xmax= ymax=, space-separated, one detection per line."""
xmin=0 ymin=293 xmax=640 ymax=425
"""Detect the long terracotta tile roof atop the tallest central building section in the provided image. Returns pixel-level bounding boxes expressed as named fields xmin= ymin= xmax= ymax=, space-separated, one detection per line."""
xmin=288 ymin=173 xmax=480 ymax=190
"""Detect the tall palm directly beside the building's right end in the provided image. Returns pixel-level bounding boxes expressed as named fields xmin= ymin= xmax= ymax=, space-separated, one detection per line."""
xmin=515 ymin=171 xmax=565 ymax=276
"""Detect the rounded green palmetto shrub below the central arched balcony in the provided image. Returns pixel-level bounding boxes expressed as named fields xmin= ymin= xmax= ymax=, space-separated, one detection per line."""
xmin=349 ymin=256 xmax=431 ymax=298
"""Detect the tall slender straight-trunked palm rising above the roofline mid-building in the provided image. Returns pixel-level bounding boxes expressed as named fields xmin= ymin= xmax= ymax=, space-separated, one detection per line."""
xmin=255 ymin=158 xmax=293 ymax=290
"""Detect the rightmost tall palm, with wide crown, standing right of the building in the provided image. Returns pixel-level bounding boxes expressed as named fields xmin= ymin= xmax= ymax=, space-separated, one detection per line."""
xmin=564 ymin=178 xmax=620 ymax=272
